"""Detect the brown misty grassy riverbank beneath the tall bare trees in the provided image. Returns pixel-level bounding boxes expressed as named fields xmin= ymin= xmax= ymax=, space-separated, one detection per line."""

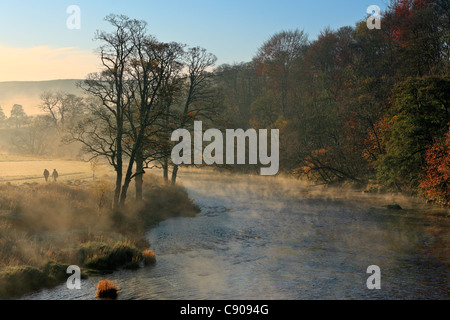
xmin=0 ymin=174 xmax=199 ymax=299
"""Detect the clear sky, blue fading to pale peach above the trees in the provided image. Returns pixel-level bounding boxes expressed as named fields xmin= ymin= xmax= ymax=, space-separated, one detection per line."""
xmin=0 ymin=0 xmax=388 ymax=81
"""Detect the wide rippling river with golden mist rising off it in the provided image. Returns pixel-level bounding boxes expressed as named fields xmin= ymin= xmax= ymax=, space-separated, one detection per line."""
xmin=23 ymin=171 xmax=450 ymax=300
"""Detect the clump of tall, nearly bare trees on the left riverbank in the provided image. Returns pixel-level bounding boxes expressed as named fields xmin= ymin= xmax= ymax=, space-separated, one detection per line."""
xmin=65 ymin=15 xmax=216 ymax=208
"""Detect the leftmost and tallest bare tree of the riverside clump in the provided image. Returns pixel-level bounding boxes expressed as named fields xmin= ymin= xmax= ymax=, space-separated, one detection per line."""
xmin=72 ymin=15 xmax=145 ymax=208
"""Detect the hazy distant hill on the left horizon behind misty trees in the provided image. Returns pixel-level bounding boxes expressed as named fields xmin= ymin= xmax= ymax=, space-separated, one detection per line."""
xmin=0 ymin=79 xmax=83 ymax=117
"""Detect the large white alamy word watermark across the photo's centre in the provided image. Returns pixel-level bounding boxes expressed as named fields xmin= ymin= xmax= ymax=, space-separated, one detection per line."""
xmin=171 ymin=121 xmax=279 ymax=176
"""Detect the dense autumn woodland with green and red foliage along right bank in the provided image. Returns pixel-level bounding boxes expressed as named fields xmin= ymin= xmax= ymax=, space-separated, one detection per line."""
xmin=215 ymin=0 xmax=450 ymax=204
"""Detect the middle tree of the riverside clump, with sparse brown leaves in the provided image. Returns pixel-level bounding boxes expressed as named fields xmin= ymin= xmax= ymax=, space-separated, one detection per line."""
xmin=120 ymin=35 xmax=183 ymax=205
